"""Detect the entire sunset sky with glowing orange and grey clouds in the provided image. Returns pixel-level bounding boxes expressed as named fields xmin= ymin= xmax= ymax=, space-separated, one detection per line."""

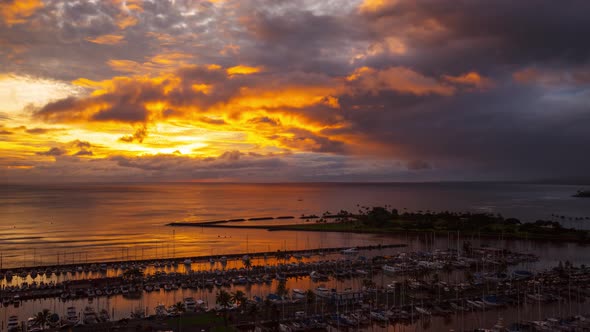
xmin=0 ymin=0 xmax=590 ymax=183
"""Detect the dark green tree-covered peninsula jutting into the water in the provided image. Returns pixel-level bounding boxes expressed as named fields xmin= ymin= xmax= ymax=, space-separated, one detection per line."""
xmin=278 ymin=207 xmax=590 ymax=242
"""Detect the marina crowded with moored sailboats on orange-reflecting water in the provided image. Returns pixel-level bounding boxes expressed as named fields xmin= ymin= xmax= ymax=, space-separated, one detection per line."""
xmin=1 ymin=244 xmax=590 ymax=331
